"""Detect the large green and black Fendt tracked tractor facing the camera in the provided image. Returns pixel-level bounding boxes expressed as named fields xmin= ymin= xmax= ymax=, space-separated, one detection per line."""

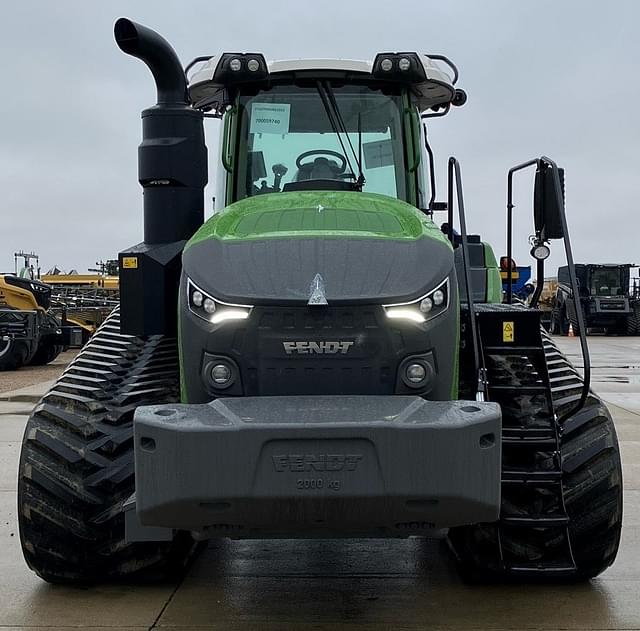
xmin=18 ymin=18 xmax=622 ymax=582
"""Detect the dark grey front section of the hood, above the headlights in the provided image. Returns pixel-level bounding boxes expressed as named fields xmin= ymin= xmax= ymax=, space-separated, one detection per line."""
xmin=183 ymin=235 xmax=453 ymax=305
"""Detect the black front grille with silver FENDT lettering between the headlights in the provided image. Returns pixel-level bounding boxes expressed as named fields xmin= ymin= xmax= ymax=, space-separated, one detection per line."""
xmin=234 ymin=306 xmax=404 ymax=395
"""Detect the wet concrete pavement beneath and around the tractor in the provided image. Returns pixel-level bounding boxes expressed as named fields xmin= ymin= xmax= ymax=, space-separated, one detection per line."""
xmin=0 ymin=337 xmax=640 ymax=631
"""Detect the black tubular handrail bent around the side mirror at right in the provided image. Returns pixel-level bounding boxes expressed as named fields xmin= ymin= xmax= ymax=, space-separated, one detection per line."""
xmin=506 ymin=156 xmax=591 ymax=423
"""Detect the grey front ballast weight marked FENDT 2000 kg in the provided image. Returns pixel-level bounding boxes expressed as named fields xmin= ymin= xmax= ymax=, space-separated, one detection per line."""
xmin=127 ymin=396 xmax=501 ymax=539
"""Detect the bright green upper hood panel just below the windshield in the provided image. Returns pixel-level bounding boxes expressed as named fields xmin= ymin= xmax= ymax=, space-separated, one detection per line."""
xmin=187 ymin=191 xmax=448 ymax=248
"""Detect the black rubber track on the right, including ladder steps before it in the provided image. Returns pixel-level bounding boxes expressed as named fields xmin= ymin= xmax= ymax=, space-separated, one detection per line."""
xmin=449 ymin=327 xmax=622 ymax=580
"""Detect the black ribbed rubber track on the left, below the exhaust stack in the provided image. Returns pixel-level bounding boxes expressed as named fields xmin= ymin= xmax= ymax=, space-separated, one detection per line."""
xmin=18 ymin=310 xmax=201 ymax=583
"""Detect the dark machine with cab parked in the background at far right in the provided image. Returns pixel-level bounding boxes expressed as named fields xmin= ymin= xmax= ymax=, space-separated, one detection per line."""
xmin=551 ymin=263 xmax=640 ymax=335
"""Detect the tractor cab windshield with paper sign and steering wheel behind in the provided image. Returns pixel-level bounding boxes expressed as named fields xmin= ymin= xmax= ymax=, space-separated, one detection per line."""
xmin=234 ymin=81 xmax=406 ymax=200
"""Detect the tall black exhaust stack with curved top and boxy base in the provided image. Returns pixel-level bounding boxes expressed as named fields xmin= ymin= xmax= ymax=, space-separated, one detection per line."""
xmin=114 ymin=18 xmax=207 ymax=335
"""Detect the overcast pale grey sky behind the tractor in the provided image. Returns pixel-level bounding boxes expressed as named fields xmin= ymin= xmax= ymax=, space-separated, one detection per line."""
xmin=0 ymin=0 xmax=640 ymax=273
